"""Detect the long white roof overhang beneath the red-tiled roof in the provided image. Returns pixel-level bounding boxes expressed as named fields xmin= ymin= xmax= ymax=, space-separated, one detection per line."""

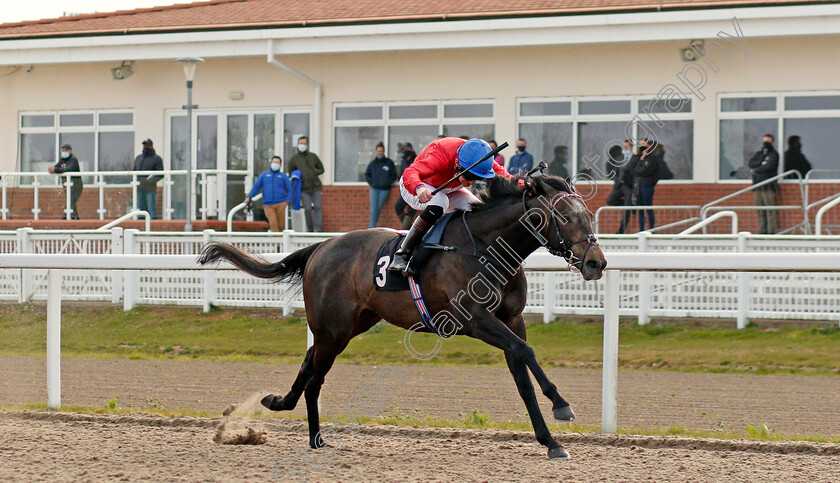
xmin=0 ymin=4 xmax=840 ymax=66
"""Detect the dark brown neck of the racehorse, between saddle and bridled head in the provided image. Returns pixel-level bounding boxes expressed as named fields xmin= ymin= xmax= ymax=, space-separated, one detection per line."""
xmin=467 ymin=203 xmax=540 ymax=265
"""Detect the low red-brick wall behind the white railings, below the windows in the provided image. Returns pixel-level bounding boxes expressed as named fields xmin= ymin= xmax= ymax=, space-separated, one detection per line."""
xmin=7 ymin=183 xmax=840 ymax=233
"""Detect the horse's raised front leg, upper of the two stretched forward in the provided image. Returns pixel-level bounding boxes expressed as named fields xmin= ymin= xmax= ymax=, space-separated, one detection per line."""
xmin=469 ymin=311 xmax=575 ymax=421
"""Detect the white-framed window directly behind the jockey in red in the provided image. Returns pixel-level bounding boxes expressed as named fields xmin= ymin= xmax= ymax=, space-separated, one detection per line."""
xmin=333 ymin=101 xmax=496 ymax=183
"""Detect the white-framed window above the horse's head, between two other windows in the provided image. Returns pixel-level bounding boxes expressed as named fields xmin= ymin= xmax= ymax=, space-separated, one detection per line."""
xmin=517 ymin=96 xmax=694 ymax=180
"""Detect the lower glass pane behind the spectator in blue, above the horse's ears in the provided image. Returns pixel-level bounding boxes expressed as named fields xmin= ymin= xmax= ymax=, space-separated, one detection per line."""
xmin=519 ymin=122 xmax=573 ymax=178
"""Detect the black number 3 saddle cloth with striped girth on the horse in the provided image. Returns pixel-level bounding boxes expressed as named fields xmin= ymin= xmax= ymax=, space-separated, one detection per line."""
xmin=373 ymin=211 xmax=460 ymax=333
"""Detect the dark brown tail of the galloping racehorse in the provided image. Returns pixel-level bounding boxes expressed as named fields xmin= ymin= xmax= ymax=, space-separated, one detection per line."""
xmin=198 ymin=242 xmax=321 ymax=284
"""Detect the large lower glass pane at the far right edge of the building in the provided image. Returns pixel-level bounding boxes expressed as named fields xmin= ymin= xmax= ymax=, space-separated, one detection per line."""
xmin=776 ymin=117 xmax=840 ymax=179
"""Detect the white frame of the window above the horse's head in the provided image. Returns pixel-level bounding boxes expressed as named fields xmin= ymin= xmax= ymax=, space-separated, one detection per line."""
xmin=516 ymin=94 xmax=697 ymax=184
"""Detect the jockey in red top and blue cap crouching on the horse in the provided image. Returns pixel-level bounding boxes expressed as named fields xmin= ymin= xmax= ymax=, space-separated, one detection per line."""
xmin=388 ymin=137 xmax=511 ymax=275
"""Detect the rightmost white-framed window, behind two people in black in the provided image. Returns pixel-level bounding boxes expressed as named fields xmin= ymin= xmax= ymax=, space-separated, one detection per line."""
xmin=718 ymin=92 xmax=840 ymax=180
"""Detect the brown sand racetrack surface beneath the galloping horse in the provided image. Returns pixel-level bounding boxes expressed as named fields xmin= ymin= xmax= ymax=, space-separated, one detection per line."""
xmin=0 ymin=356 xmax=840 ymax=483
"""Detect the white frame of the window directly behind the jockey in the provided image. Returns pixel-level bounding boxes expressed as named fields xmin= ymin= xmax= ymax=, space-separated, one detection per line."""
xmin=330 ymin=99 xmax=496 ymax=186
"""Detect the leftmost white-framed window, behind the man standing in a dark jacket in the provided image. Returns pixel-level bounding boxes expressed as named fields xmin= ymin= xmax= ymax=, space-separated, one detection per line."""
xmin=20 ymin=110 xmax=137 ymax=184
